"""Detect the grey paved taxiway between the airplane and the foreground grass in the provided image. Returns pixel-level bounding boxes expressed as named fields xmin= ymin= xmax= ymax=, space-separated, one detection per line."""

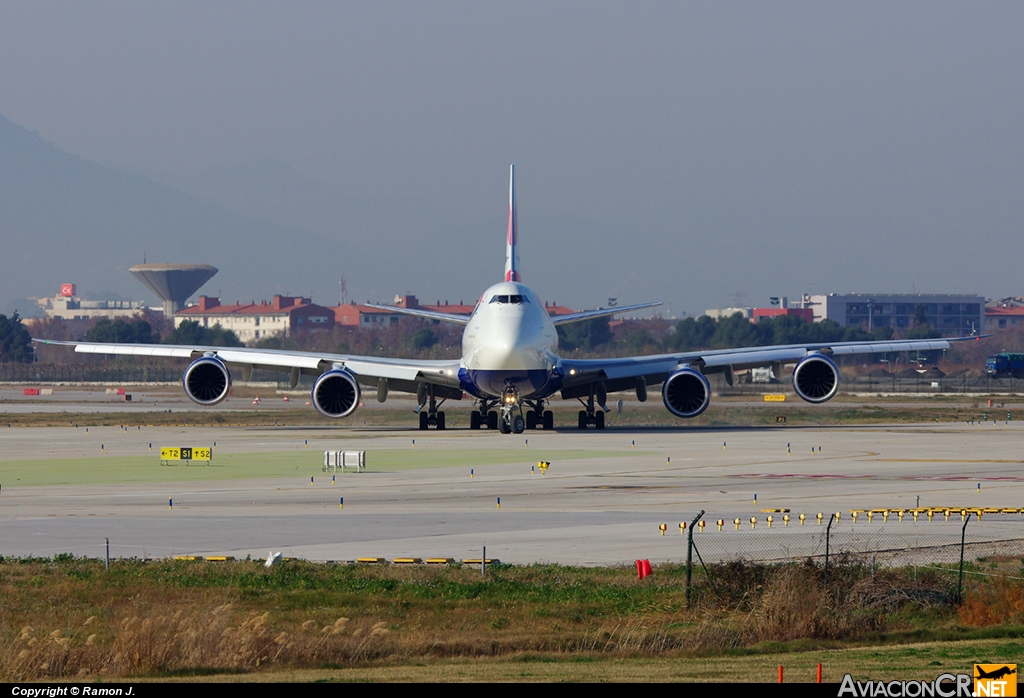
xmin=0 ymin=415 xmax=1024 ymax=565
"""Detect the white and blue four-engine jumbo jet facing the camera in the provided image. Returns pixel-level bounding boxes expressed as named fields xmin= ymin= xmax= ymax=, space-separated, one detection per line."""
xmin=35 ymin=166 xmax=977 ymax=434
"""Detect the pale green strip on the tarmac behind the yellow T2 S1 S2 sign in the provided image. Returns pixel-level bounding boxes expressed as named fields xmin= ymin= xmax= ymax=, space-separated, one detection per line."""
xmin=0 ymin=444 xmax=645 ymax=487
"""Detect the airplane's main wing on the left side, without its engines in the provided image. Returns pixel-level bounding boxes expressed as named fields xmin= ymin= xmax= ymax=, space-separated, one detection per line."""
xmin=33 ymin=339 xmax=462 ymax=399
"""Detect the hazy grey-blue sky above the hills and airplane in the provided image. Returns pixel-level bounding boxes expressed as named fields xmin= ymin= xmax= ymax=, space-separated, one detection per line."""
xmin=0 ymin=1 xmax=1024 ymax=315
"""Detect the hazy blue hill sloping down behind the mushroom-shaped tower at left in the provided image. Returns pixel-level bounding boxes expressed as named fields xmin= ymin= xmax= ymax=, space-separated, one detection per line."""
xmin=0 ymin=116 xmax=346 ymax=315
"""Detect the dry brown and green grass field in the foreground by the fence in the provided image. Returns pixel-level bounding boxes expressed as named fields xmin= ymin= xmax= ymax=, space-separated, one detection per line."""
xmin=0 ymin=556 xmax=1024 ymax=682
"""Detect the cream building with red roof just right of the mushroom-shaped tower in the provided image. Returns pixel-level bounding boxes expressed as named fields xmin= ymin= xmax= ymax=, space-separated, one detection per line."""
xmin=174 ymin=296 xmax=335 ymax=342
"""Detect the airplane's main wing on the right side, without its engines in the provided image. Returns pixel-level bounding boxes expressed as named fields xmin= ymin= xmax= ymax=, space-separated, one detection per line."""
xmin=559 ymin=335 xmax=989 ymax=397
